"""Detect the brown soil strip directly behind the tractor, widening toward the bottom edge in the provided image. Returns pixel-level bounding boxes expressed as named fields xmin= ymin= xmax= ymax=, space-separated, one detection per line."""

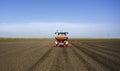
xmin=49 ymin=47 xmax=74 ymax=71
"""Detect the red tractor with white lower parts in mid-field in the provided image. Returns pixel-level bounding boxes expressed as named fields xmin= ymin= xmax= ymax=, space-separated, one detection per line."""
xmin=55 ymin=32 xmax=68 ymax=47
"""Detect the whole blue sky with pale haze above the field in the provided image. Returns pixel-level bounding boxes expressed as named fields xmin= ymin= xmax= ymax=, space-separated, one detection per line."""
xmin=0 ymin=0 xmax=120 ymax=38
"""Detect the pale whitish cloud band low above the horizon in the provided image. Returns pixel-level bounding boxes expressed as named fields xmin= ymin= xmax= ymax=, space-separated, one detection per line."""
xmin=0 ymin=22 xmax=120 ymax=38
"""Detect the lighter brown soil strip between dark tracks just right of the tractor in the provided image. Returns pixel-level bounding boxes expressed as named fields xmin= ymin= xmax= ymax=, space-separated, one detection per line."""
xmin=72 ymin=44 xmax=106 ymax=71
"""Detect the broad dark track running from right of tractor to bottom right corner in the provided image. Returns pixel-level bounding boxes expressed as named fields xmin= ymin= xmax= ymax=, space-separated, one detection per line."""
xmin=71 ymin=43 xmax=120 ymax=71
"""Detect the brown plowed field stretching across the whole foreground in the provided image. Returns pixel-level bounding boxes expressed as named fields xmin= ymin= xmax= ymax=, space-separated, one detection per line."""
xmin=0 ymin=39 xmax=120 ymax=71
